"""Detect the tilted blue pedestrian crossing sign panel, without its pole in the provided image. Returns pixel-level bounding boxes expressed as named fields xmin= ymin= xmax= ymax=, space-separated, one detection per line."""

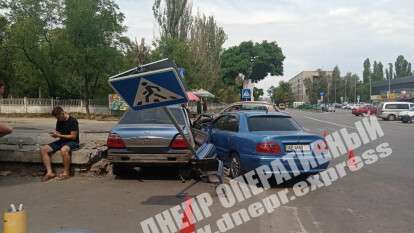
xmin=109 ymin=67 xmax=188 ymax=111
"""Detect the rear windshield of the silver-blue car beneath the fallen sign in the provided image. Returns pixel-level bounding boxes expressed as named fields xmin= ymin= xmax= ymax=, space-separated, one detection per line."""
xmin=119 ymin=108 xmax=185 ymax=125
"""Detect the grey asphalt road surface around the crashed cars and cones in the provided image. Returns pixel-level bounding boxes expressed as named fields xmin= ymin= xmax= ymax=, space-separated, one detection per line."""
xmin=0 ymin=111 xmax=414 ymax=233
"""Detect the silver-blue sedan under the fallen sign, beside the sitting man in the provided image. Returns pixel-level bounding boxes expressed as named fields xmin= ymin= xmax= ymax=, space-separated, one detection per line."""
xmin=107 ymin=106 xmax=194 ymax=175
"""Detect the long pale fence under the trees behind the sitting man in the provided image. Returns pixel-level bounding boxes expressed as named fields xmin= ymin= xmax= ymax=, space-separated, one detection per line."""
xmin=0 ymin=98 xmax=109 ymax=114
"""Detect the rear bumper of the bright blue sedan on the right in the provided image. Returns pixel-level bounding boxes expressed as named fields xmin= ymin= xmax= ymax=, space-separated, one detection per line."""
xmin=240 ymin=154 xmax=329 ymax=175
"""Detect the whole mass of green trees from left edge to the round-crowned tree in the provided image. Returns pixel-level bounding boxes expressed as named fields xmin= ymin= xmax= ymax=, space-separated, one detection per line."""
xmin=0 ymin=0 xmax=284 ymax=111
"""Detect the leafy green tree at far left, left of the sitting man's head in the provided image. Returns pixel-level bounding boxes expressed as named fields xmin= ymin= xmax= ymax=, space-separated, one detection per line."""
xmin=3 ymin=0 xmax=65 ymax=96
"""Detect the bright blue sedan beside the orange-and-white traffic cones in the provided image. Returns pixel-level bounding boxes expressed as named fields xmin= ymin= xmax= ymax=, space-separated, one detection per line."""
xmin=209 ymin=112 xmax=328 ymax=178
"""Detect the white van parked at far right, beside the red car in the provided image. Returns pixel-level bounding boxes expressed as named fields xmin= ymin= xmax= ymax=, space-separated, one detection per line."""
xmin=377 ymin=102 xmax=414 ymax=121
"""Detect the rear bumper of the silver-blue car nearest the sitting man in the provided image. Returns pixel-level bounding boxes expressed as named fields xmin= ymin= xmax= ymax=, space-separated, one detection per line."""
xmin=107 ymin=153 xmax=191 ymax=166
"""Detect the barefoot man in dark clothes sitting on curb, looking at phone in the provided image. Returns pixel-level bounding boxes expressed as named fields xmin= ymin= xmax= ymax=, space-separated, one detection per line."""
xmin=40 ymin=107 xmax=79 ymax=181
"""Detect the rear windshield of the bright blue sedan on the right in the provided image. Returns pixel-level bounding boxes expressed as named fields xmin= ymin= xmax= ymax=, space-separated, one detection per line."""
xmin=247 ymin=116 xmax=300 ymax=132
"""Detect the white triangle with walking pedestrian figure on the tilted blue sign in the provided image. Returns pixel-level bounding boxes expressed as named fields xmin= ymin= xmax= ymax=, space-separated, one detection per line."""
xmin=134 ymin=78 xmax=184 ymax=107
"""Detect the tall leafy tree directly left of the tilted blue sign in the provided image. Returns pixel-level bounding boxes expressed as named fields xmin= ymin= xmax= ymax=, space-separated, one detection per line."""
xmin=64 ymin=0 xmax=125 ymax=115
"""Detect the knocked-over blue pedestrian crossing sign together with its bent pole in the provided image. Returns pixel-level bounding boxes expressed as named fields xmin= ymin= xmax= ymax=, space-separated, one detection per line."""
xmin=109 ymin=59 xmax=196 ymax=157
